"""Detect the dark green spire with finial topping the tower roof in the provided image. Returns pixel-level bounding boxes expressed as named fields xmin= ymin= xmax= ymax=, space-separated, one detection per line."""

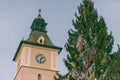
xmin=31 ymin=9 xmax=47 ymax=32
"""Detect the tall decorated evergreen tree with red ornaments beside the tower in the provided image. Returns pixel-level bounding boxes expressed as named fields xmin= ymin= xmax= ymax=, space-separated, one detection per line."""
xmin=55 ymin=0 xmax=114 ymax=80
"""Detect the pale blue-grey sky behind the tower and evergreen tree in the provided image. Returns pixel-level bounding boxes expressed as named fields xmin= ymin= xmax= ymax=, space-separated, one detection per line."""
xmin=0 ymin=0 xmax=120 ymax=80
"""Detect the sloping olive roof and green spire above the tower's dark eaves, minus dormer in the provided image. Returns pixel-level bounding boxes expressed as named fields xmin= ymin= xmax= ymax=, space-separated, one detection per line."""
xmin=27 ymin=9 xmax=55 ymax=46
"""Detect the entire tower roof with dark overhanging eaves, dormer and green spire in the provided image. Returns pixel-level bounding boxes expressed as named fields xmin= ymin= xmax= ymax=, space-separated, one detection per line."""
xmin=13 ymin=10 xmax=62 ymax=61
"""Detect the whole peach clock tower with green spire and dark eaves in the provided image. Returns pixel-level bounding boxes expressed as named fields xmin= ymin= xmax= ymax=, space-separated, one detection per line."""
xmin=13 ymin=10 xmax=62 ymax=80
